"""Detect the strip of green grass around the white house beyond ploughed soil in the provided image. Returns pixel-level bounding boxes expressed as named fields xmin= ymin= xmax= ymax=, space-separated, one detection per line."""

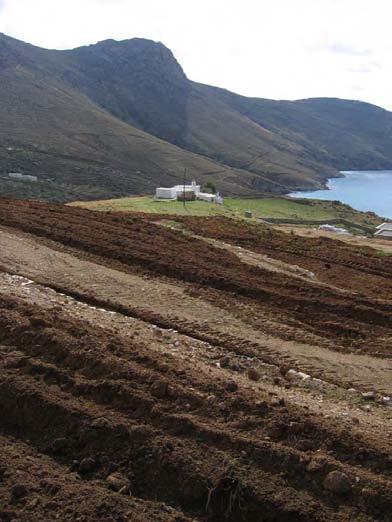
xmin=70 ymin=196 xmax=381 ymax=227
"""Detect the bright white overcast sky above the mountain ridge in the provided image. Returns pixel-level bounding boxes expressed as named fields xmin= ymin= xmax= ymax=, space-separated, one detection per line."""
xmin=0 ymin=0 xmax=392 ymax=110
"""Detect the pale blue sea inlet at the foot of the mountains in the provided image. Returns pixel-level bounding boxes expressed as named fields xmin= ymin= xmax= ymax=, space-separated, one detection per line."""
xmin=289 ymin=170 xmax=392 ymax=219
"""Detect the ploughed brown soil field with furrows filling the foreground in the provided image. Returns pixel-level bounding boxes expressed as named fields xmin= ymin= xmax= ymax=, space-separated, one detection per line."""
xmin=0 ymin=200 xmax=392 ymax=522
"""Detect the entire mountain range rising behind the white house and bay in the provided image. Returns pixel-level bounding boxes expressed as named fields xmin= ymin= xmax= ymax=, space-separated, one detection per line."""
xmin=0 ymin=35 xmax=392 ymax=201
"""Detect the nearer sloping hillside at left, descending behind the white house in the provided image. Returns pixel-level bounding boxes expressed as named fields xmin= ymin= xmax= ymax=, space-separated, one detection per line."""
xmin=0 ymin=34 xmax=258 ymax=201
